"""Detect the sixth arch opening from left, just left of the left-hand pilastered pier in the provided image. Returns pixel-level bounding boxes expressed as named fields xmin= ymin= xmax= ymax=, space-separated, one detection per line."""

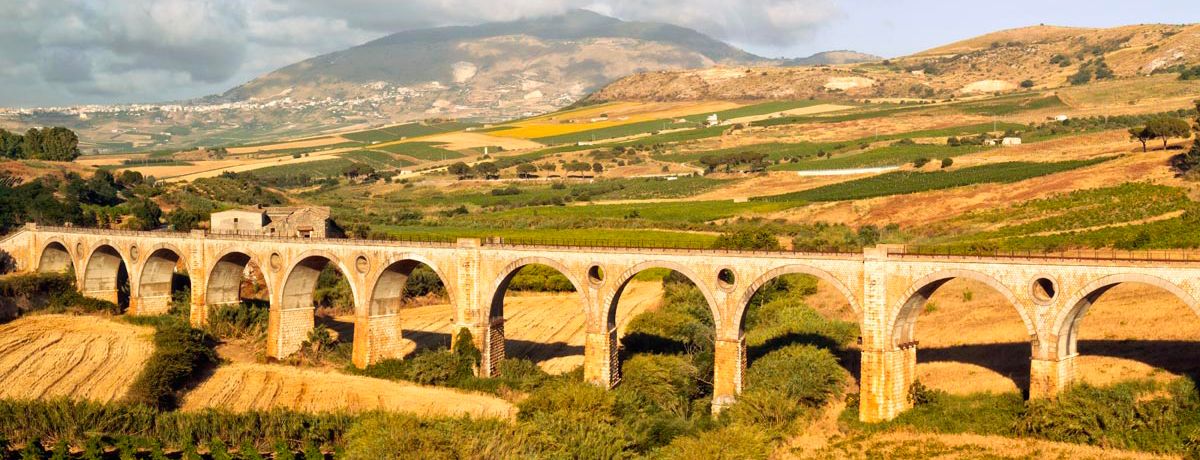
xmin=367 ymin=259 xmax=456 ymax=354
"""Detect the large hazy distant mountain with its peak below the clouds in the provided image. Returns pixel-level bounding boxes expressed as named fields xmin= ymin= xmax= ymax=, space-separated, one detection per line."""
xmin=220 ymin=10 xmax=768 ymax=119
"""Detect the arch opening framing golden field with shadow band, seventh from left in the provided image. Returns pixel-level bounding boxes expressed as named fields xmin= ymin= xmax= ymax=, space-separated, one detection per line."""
xmin=486 ymin=259 xmax=587 ymax=374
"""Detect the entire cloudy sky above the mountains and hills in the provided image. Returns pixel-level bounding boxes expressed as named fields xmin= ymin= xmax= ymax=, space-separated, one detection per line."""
xmin=0 ymin=0 xmax=1200 ymax=107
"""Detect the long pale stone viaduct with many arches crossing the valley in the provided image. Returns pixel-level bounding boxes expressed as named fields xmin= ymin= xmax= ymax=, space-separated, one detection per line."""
xmin=0 ymin=225 xmax=1200 ymax=422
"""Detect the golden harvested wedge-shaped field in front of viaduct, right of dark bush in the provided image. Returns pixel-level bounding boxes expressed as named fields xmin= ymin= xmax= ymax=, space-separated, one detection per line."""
xmin=182 ymin=363 xmax=516 ymax=418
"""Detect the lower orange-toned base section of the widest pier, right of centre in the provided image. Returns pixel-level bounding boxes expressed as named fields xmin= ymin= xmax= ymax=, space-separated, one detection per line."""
xmin=858 ymin=342 xmax=917 ymax=422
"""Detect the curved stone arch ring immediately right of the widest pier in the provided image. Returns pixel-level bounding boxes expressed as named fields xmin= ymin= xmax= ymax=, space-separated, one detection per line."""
xmin=886 ymin=269 xmax=1037 ymax=346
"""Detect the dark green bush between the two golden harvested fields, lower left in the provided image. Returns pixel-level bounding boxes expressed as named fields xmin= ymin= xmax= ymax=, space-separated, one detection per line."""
xmin=126 ymin=317 xmax=217 ymax=410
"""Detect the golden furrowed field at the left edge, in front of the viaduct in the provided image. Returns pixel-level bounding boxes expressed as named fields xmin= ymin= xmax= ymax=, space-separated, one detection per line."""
xmin=0 ymin=315 xmax=154 ymax=402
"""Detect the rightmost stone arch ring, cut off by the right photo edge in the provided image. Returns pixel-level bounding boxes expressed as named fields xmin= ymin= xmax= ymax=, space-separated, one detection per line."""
xmin=1051 ymin=274 xmax=1200 ymax=359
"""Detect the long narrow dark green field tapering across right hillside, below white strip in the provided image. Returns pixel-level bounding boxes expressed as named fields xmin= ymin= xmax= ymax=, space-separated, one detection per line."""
xmin=758 ymin=157 xmax=1110 ymax=202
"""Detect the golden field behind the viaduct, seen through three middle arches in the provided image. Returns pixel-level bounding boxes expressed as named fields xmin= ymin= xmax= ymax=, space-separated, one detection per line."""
xmin=391 ymin=281 xmax=662 ymax=374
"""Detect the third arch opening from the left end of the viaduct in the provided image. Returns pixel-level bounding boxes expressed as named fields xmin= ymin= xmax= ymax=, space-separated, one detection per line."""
xmin=138 ymin=247 xmax=192 ymax=313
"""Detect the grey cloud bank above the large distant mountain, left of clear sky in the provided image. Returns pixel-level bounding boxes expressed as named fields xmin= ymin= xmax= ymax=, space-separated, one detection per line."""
xmin=0 ymin=0 xmax=839 ymax=106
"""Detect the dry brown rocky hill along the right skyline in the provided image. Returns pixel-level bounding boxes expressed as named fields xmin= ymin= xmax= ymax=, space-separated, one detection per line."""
xmin=590 ymin=24 xmax=1200 ymax=101
